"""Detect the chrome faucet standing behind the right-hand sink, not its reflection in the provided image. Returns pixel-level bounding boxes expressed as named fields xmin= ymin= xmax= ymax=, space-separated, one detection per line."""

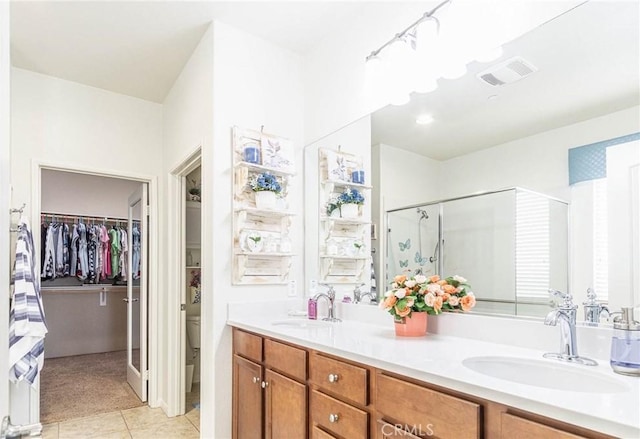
xmin=543 ymin=290 xmax=598 ymax=366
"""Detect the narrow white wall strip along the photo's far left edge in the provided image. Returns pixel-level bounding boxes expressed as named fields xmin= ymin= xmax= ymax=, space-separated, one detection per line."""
xmin=0 ymin=2 xmax=11 ymax=422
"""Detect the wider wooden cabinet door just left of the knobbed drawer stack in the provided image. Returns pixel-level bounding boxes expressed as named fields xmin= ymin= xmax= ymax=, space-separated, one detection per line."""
xmin=265 ymin=369 xmax=307 ymax=439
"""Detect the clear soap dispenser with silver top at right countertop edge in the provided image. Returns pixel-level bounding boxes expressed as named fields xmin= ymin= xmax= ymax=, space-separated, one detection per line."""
xmin=611 ymin=308 xmax=640 ymax=376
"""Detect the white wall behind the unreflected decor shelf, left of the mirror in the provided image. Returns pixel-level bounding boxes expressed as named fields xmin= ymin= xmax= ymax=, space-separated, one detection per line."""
xmin=210 ymin=22 xmax=304 ymax=438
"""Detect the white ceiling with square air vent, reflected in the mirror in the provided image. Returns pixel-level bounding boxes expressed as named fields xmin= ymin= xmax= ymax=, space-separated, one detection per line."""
xmin=372 ymin=1 xmax=640 ymax=160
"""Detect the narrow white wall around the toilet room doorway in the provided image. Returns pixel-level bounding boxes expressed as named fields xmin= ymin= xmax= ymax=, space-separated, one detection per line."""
xmin=158 ymin=22 xmax=214 ymax=424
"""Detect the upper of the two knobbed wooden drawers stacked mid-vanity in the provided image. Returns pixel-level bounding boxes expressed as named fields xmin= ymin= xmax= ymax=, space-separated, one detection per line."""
xmin=309 ymin=354 xmax=369 ymax=406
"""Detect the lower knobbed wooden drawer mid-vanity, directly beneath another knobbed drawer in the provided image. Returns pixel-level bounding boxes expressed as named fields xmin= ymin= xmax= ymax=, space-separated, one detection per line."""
xmin=309 ymin=390 xmax=369 ymax=439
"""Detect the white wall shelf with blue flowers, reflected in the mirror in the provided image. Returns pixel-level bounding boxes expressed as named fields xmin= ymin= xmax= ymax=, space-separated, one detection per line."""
xmin=318 ymin=148 xmax=371 ymax=284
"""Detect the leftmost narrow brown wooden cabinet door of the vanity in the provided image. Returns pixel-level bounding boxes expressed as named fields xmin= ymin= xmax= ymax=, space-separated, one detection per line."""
xmin=233 ymin=355 xmax=263 ymax=439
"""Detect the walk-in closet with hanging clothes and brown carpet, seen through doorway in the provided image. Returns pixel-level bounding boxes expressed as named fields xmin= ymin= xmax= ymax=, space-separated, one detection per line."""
xmin=40 ymin=169 xmax=146 ymax=424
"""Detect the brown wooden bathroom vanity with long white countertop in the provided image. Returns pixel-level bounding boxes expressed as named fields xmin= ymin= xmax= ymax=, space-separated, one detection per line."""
xmin=228 ymin=306 xmax=640 ymax=439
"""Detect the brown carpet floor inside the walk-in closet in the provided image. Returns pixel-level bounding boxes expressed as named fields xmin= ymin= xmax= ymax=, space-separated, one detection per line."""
xmin=40 ymin=351 xmax=145 ymax=424
